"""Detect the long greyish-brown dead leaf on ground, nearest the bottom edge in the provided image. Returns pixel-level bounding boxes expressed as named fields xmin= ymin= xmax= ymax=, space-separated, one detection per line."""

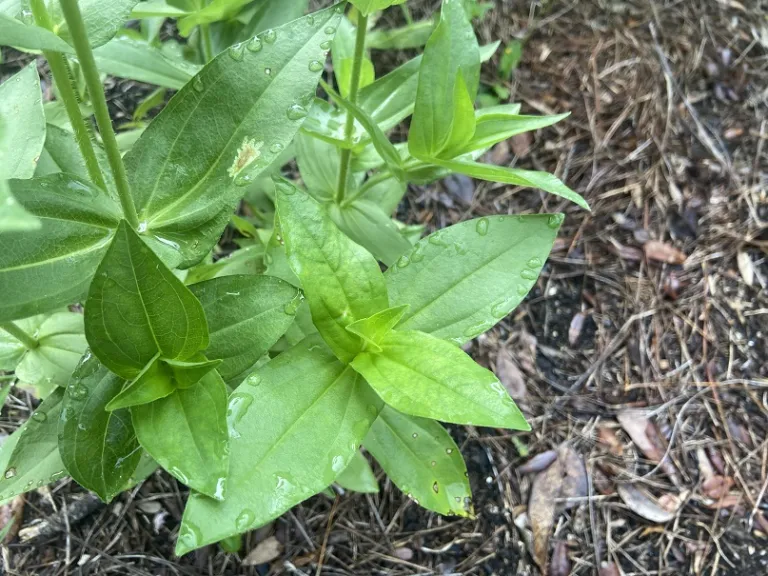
xmin=528 ymin=444 xmax=587 ymax=574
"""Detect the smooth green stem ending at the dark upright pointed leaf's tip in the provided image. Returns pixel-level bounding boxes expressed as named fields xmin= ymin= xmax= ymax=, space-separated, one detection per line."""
xmin=60 ymin=0 xmax=139 ymax=228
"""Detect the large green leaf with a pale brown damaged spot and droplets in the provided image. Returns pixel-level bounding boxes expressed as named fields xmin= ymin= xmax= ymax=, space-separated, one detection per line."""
xmin=125 ymin=7 xmax=339 ymax=267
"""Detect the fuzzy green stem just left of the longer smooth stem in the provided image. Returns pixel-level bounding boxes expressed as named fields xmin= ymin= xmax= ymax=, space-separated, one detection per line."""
xmin=30 ymin=0 xmax=107 ymax=190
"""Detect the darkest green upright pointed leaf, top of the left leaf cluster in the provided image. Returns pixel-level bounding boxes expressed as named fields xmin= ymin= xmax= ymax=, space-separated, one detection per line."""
xmin=85 ymin=220 xmax=208 ymax=379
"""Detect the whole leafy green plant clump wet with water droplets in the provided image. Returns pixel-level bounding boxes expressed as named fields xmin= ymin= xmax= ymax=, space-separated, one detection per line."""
xmin=0 ymin=0 xmax=586 ymax=554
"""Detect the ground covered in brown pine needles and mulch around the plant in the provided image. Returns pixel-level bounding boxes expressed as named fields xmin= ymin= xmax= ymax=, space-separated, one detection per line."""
xmin=1 ymin=0 xmax=768 ymax=576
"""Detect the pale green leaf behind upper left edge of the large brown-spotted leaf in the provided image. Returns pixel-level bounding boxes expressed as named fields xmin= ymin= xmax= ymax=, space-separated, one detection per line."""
xmin=93 ymin=36 xmax=199 ymax=90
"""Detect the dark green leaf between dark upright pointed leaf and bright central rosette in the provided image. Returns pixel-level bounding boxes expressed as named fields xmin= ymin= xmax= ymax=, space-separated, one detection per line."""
xmin=189 ymin=276 xmax=300 ymax=386
